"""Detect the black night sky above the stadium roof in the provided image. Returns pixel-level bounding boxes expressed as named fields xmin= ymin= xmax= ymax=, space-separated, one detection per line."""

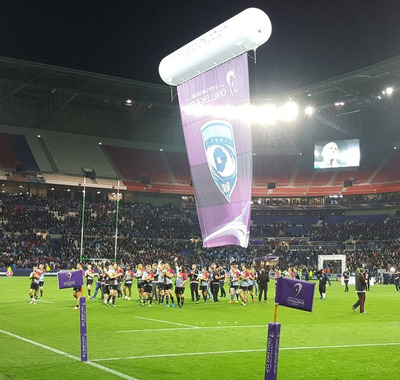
xmin=0 ymin=0 xmax=400 ymax=93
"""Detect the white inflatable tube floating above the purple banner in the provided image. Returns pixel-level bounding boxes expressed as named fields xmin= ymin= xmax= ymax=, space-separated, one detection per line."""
xmin=158 ymin=8 xmax=272 ymax=86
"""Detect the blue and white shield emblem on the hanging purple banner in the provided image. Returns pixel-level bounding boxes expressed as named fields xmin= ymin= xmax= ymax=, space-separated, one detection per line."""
xmin=201 ymin=120 xmax=237 ymax=202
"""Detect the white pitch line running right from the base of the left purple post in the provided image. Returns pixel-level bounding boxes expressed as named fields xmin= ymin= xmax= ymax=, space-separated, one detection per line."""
xmin=92 ymin=343 xmax=400 ymax=362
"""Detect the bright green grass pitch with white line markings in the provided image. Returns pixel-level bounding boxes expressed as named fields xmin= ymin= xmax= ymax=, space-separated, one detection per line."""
xmin=0 ymin=277 xmax=400 ymax=380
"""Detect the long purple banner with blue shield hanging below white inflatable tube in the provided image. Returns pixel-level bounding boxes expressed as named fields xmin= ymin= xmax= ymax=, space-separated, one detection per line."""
xmin=178 ymin=54 xmax=253 ymax=247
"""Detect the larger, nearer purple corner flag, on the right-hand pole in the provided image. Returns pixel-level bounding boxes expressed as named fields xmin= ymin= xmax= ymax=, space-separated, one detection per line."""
xmin=275 ymin=277 xmax=315 ymax=311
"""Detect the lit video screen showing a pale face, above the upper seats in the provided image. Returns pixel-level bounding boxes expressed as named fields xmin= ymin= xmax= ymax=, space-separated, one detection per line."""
xmin=314 ymin=139 xmax=360 ymax=169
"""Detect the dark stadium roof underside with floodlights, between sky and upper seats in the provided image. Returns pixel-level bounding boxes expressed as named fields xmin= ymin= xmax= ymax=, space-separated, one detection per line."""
xmin=0 ymin=56 xmax=400 ymax=149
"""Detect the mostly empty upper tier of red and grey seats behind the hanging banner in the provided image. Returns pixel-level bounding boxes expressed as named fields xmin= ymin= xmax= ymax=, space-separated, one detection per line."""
xmin=0 ymin=129 xmax=400 ymax=198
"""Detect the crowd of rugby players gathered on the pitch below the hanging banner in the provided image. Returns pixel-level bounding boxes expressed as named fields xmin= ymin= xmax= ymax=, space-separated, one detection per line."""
xmin=29 ymin=261 xmax=268 ymax=309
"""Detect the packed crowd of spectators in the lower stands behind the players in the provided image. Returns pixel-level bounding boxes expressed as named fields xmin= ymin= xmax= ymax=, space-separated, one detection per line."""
xmin=0 ymin=193 xmax=400 ymax=272
